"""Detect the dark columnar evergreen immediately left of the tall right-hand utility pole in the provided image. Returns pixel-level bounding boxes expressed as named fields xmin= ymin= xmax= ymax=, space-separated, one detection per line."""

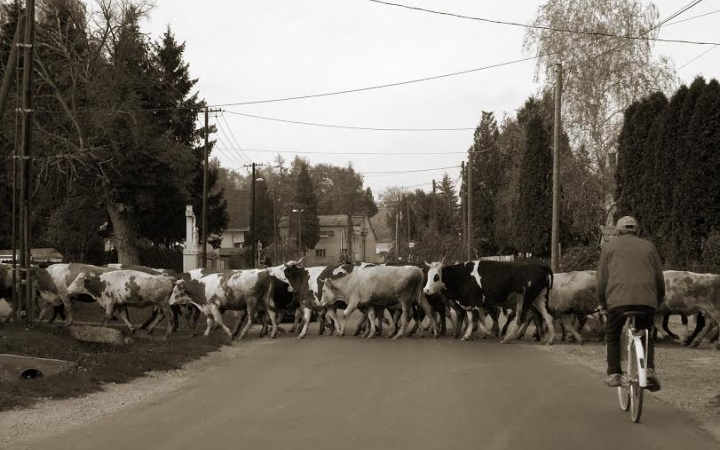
xmin=518 ymin=116 xmax=553 ymax=256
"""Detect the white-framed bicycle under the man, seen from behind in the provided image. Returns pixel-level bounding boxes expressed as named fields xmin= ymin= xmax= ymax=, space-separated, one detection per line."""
xmin=618 ymin=311 xmax=650 ymax=423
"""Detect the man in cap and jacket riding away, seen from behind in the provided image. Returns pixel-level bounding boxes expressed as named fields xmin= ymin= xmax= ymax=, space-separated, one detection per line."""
xmin=597 ymin=216 xmax=665 ymax=392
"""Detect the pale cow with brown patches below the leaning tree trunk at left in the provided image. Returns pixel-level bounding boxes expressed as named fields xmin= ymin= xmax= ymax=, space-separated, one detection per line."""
xmin=67 ymin=270 xmax=173 ymax=336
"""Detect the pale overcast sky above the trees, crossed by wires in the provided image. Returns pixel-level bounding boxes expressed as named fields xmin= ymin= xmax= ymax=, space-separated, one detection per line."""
xmin=138 ymin=0 xmax=720 ymax=198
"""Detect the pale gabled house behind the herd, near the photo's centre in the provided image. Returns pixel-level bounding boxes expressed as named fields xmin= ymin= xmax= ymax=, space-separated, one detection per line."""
xmin=278 ymin=214 xmax=382 ymax=266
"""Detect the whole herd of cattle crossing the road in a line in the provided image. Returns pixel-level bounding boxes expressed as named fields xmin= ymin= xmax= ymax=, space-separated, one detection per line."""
xmin=0 ymin=260 xmax=720 ymax=349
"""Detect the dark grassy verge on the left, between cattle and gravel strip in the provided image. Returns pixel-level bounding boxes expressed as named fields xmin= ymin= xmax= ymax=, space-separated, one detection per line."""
xmin=0 ymin=326 xmax=224 ymax=411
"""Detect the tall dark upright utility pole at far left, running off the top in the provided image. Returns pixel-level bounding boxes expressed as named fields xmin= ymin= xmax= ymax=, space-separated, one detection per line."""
xmin=19 ymin=0 xmax=35 ymax=322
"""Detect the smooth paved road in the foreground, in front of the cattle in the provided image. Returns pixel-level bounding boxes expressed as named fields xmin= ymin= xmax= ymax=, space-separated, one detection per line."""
xmin=2 ymin=326 xmax=718 ymax=450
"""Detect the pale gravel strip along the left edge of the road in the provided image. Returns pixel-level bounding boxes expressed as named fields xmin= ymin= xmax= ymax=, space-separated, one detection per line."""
xmin=0 ymin=342 xmax=252 ymax=447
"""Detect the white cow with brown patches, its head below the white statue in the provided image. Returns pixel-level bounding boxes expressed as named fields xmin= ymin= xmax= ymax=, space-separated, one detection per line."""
xmin=170 ymin=269 xmax=277 ymax=340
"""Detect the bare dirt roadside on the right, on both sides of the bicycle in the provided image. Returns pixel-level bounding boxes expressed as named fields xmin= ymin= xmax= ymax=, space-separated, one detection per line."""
xmin=537 ymin=342 xmax=720 ymax=441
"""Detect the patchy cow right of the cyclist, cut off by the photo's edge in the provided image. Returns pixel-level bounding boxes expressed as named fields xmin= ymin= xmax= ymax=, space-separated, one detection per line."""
xmin=658 ymin=270 xmax=720 ymax=349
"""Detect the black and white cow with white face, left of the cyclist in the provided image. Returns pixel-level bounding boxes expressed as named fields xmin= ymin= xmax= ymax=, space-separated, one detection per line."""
xmin=424 ymin=261 xmax=555 ymax=344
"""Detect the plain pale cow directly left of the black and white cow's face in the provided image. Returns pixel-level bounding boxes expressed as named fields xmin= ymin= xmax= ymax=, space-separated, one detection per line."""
xmin=320 ymin=266 xmax=438 ymax=339
